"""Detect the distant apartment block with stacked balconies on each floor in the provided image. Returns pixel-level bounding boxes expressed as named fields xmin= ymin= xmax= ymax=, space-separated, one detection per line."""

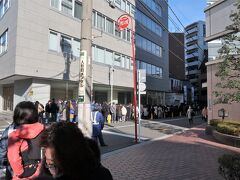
xmin=185 ymin=21 xmax=207 ymax=102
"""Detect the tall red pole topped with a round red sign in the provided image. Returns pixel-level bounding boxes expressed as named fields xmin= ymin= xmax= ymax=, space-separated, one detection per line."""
xmin=117 ymin=14 xmax=137 ymax=143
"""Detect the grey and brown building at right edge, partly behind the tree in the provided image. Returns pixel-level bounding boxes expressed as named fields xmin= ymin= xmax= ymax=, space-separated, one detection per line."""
xmin=204 ymin=0 xmax=240 ymax=120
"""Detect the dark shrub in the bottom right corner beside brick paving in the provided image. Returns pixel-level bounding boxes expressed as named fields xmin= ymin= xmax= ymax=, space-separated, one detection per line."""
xmin=218 ymin=154 xmax=240 ymax=180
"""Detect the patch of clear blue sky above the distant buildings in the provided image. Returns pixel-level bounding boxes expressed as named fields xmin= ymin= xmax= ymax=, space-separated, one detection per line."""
xmin=168 ymin=0 xmax=207 ymax=32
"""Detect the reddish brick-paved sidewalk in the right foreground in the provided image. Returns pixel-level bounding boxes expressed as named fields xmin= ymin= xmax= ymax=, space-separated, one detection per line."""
xmin=102 ymin=127 xmax=240 ymax=180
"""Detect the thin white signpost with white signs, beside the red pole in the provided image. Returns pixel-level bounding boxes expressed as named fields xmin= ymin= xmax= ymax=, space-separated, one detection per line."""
xmin=138 ymin=69 xmax=146 ymax=142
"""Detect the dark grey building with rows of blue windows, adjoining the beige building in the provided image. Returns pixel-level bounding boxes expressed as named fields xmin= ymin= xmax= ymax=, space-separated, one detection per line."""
xmin=135 ymin=0 xmax=169 ymax=104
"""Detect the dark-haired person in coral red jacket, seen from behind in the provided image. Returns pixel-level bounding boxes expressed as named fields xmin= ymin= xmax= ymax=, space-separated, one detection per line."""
xmin=7 ymin=101 xmax=44 ymax=179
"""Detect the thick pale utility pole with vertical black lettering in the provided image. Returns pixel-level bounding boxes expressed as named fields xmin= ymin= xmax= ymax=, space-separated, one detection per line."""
xmin=78 ymin=0 xmax=92 ymax=137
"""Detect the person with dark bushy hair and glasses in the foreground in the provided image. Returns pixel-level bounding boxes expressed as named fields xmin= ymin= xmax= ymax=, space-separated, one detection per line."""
xmin=39 ymin=122 xmax=112 ymax=180
